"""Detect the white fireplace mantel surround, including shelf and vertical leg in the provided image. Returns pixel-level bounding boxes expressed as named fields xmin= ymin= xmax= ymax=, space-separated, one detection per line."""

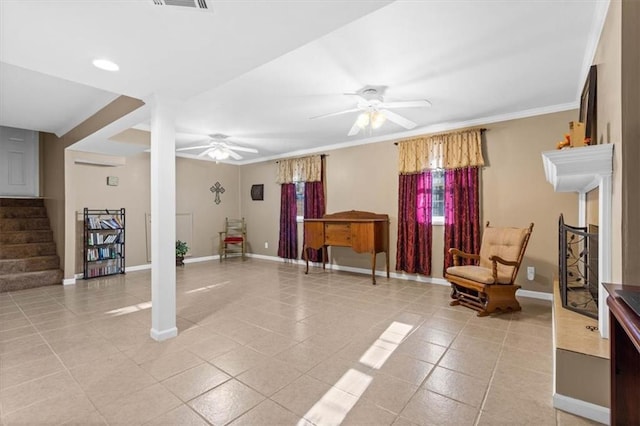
xmin=542 ymin=144 xmax=613 ymax=337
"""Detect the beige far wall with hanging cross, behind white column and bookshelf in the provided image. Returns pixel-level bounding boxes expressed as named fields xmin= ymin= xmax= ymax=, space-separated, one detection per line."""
xmin=67 ymin=151 xmax=240 ymax=273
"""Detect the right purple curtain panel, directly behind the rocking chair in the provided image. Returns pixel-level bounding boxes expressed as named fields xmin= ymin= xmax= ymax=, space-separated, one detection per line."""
xmin=443 ymin=167 xmax=480 ymax=272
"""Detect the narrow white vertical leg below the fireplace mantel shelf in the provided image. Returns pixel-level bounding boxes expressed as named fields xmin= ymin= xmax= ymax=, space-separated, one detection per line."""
xmin=598 ymin=174 xmax=612 ymax=338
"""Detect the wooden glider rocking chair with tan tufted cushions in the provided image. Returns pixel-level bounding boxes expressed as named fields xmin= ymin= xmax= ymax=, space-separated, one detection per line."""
xmin=444 ymin=222 xmax=533 ymax=317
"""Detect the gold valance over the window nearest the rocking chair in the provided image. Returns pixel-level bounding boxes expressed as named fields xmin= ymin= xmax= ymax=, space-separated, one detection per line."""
xmin=398 ymin=129 xmax=484 ymax=174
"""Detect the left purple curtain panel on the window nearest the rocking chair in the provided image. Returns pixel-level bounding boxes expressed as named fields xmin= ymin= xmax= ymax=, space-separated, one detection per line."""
xmin=396 ymin=172 xmax=432 ymax=275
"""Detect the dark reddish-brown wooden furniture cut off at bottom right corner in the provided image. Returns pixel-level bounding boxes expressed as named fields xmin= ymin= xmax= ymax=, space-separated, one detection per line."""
xmin=604 ymin=284 xmax=640 ymax=425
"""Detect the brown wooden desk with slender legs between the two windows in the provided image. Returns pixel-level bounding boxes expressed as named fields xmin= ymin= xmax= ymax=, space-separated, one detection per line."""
xmin=302 ymin=210 xmax=389 ymax=284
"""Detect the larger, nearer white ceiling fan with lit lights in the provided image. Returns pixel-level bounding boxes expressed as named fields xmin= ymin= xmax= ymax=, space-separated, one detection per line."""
xmin=311 ymin=86 xmax=431 ymax=136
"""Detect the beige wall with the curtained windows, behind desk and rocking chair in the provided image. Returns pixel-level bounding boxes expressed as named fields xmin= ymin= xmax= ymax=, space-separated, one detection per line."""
xmin=241 ymin=111 xmax=578 ymax=292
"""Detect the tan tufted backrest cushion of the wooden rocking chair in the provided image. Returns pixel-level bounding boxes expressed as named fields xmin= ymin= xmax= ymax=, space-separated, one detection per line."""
xmin=480 ymin=227 xmax=528 ymax=283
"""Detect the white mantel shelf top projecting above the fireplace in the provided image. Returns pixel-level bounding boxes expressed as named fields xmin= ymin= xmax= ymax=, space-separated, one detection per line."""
xmin=542 ymin=144 xmax=613 ymax=193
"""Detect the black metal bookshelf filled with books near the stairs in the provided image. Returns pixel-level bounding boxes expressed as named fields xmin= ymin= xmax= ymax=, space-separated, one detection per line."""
xmin=83 ymin=207 xmax=125 ymax=279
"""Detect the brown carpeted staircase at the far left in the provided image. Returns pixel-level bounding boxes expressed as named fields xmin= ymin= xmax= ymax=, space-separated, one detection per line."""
xmin=0 ymin=198 xmax=63 ymax=293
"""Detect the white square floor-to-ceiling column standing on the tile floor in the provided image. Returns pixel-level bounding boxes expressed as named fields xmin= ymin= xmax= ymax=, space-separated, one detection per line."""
xmin=151 ymin=95 xmax=178 ymax=341
